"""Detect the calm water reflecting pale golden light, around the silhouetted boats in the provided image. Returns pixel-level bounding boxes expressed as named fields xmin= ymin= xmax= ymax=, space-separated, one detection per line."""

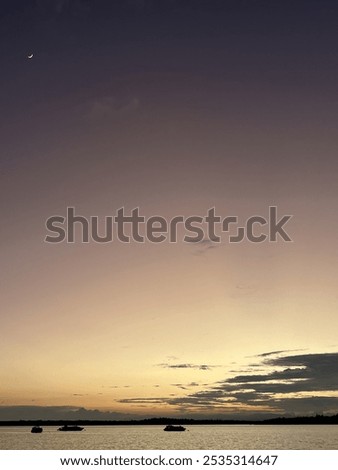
xmin=0 ymin=425 xmax=338 ymax=450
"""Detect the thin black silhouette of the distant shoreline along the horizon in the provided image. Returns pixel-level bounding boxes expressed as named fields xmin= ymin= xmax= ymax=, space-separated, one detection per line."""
xmin=0 ymin=414 xmax=338 ymax=426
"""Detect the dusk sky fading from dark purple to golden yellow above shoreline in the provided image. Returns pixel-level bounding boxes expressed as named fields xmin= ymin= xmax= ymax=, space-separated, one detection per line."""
xmin=0 ymin=0 xmax=338 ymax=420
